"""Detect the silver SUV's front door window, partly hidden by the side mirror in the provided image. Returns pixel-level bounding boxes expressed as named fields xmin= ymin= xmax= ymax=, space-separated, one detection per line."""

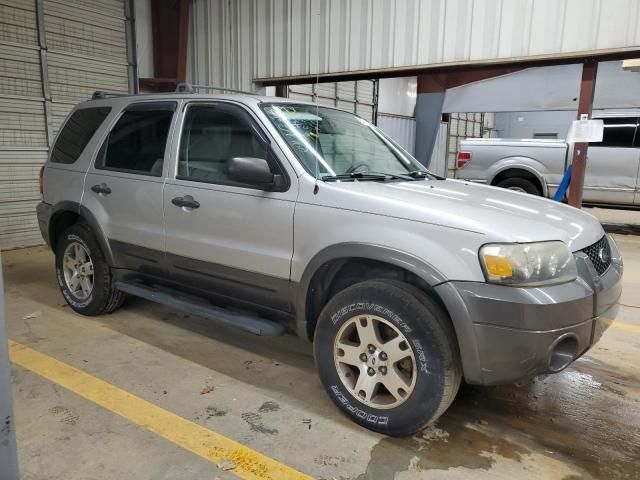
xmin=178 ymin=105 xmax=268 ymax=184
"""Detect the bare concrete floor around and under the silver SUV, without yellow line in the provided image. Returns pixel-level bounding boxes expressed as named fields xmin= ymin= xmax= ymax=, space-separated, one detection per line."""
xmin=3 ymin=236 xmax=640 ymax=480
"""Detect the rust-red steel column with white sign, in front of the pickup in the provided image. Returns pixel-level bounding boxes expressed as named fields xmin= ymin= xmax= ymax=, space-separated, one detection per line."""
xmin=569 ymin=60 xmax=598 ymax=208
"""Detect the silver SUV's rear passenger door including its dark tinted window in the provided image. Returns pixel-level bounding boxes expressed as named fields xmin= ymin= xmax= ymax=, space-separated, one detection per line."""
xmin=82 ymin=102 xmax=177 ymax=275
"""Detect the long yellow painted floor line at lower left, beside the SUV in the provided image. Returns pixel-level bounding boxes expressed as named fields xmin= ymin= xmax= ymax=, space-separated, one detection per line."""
xmin=9 ymin=340 xmax=312 ymax=480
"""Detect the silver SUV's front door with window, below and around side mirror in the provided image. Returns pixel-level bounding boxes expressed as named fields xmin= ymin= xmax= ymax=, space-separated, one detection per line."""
xmin=164 ymin=102 xmax=297 ymax=311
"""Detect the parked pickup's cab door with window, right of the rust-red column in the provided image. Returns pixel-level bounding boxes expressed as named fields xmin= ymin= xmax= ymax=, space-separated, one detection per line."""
xmin=583 ymin=117 xmax=640 ymax=205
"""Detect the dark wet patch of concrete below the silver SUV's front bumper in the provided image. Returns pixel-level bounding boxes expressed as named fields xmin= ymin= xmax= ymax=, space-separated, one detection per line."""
xmin=359 ymin=359 xmax=640 ymax=480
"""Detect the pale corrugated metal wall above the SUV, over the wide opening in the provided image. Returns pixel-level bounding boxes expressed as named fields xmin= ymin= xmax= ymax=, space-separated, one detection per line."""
xmin=189 ymin=0 xmax=640 ymax=90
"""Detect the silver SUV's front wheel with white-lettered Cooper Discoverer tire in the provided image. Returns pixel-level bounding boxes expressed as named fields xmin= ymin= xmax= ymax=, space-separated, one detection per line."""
xmin=314 ymin=280 xmax=461 ymax=436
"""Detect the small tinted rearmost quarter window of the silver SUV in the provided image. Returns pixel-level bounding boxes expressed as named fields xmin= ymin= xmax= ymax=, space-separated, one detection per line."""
xmin=51 ymin=107 xmax=111 ymax=164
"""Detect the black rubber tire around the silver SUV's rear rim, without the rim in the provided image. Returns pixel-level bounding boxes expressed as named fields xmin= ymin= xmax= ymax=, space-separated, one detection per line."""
xmin=56 ymin=223 xmax=125 ymax=315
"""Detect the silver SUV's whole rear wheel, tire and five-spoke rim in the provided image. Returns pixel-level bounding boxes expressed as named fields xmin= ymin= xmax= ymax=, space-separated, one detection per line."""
xmin=56 ymin=223 xmax=125 ymax=315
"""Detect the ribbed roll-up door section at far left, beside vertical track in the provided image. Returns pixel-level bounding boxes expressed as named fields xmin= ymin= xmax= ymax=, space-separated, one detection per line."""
xmin=0 ymin=0 xmax=48 ymax=248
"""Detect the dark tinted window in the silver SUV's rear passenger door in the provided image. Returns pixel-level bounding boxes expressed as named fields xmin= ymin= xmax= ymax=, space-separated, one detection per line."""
xmin=96 ymin=102 xmax=176 ymax=177
